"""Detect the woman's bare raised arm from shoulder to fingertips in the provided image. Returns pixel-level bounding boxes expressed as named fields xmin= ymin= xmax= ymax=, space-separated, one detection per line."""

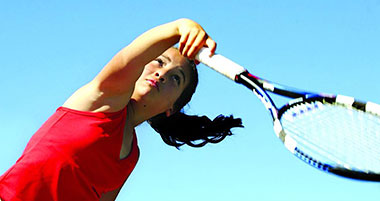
xmin=63 ymin=19 xmax=216 ymax=112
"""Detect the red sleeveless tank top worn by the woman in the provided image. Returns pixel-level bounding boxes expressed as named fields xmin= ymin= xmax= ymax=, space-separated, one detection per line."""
xmin=0 ymin=107 xmax=139 ymax=201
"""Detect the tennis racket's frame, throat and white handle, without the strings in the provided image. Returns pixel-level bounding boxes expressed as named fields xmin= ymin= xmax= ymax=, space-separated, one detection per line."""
xmin=196 ymin=48 xmax=380 ymax=181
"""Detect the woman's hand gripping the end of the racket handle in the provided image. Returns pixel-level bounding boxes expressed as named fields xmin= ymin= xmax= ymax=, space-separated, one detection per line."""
xmin=178 ymin=19 xmax=216 ymax=59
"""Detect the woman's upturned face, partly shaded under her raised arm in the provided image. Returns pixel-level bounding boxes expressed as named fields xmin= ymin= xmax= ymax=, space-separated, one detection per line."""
xmin=132 ymin=48 xmax=191 ymax=116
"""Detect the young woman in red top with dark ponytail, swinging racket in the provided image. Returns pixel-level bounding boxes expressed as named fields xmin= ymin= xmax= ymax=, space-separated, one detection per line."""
xmin=0 ymin=19 xmax=241 ymax=201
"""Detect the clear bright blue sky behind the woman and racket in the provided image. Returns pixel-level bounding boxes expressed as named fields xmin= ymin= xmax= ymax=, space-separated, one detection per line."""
xmin=0 ymin=0 xmax=380 ymax=201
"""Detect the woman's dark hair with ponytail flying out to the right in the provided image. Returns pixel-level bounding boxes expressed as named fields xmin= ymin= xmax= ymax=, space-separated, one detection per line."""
xmin=148 ymin=54 xmax=243 ymax=149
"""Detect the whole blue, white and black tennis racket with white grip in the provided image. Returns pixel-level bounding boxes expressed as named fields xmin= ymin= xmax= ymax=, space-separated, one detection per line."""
xmin=196 ymin=48 xmax=380 ymax=181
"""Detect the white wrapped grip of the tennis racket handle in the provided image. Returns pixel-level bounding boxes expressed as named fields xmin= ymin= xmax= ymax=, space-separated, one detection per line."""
xmin=195 ymin=48 xmax=246 ymax=81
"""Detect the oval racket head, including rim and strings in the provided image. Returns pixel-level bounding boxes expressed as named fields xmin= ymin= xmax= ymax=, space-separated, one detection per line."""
xmin=274 ymin=95 xmax=380 ymax=181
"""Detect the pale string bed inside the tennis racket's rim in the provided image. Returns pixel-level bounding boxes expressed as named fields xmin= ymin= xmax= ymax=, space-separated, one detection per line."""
xmin=281 ymin=102 xmax=380 ymax=173
